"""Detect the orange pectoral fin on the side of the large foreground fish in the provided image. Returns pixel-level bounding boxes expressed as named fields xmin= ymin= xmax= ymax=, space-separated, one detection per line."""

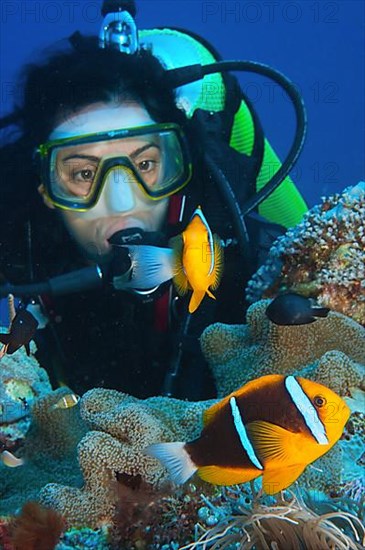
xmin=246 ymin=420 xmax=294 ymax=467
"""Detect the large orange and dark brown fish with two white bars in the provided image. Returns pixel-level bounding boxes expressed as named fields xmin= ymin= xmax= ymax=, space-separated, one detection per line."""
xmin=146 ymin=374 xmax=350 ymax=494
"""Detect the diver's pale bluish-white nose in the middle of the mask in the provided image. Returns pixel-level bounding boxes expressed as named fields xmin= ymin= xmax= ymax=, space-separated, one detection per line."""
xmin=103 ymin=167 xmax=136 ymax=212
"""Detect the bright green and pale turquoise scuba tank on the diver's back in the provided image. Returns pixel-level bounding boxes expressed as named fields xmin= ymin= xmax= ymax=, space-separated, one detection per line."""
xmin=139 ymin=28 xmax=307 ymax=228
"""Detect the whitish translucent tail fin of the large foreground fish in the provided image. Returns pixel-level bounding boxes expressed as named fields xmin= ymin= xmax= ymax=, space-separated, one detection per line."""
xmin=145 ymin=441 xmax=198 ymax=485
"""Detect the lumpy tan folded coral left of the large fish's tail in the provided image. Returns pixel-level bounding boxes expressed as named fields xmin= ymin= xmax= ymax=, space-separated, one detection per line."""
xmin=40 ymin=388 xmax=211 ymax=528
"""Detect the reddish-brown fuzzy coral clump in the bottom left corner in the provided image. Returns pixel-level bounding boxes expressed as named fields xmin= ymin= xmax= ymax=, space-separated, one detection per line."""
xmin=10 ymin=502 xmax=65 ymax=550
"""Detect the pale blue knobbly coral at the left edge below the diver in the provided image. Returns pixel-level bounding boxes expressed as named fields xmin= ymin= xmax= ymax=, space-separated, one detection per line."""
xmin=0 ymin=342 xmax=52 ymax=448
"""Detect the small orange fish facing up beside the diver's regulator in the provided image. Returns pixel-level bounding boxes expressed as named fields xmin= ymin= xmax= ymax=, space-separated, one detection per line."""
xmin=170 ymin=206 xmax=223 ymax=313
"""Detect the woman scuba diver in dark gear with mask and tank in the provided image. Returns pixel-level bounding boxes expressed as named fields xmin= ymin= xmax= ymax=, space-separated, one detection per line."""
xmin=0 ymin=0 xmax=306 ymax=400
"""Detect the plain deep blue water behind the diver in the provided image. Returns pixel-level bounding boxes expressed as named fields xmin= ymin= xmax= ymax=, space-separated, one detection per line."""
xmin=0 ymin=0 xmax=365 ymax=206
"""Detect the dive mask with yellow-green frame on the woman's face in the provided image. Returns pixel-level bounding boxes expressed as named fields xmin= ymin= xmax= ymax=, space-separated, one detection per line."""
xmin=36 ymin=123 xmax=192 ymax=211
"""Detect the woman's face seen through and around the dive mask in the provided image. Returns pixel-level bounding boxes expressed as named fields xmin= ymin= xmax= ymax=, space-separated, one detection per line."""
xmin=39 ymin=102 xmax=168 ymax=262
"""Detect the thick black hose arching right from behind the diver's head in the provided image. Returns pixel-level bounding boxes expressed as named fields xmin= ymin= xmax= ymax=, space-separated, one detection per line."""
xmin=164 ymin=61 xmax=307 ymax=217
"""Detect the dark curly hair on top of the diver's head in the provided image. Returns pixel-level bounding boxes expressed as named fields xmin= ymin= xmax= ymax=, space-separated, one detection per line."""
xmin=13 ymin=36 xmax=186 ymax=146
